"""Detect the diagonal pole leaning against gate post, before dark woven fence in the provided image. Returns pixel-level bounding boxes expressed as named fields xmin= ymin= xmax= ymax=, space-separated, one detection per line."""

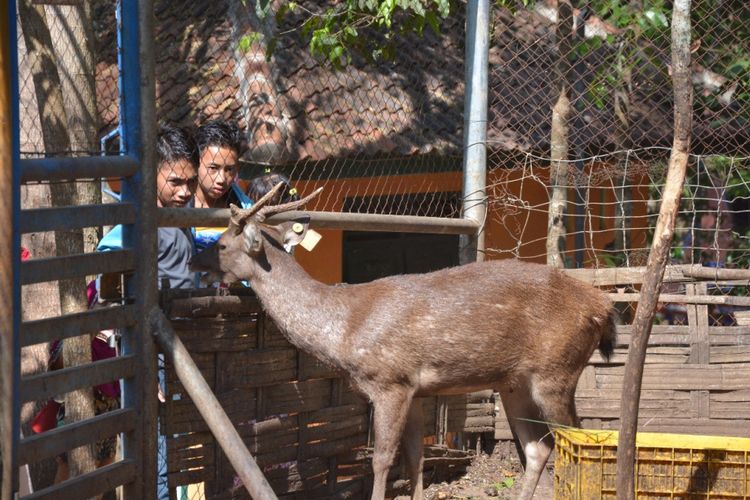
xmin=148 ymin=307 xmax=277 ymax=500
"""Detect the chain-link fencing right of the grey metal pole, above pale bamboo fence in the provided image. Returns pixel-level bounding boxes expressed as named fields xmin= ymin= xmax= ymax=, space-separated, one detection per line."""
xmin=488 ymin=0 xmax=750 ymax=267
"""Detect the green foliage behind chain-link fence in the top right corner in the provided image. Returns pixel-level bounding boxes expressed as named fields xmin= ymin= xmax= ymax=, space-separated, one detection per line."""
xmin=575 ymin=0 xmax=750 ymax=131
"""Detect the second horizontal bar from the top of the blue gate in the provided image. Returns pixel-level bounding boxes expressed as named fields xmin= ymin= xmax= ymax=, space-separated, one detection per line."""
xmin=21 ymin=203 xmax=135 ymax=233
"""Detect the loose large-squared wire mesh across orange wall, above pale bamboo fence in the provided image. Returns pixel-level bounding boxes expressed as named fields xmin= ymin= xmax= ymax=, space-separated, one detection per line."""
xmin=487 ymin=148 xmax=750 ymax=268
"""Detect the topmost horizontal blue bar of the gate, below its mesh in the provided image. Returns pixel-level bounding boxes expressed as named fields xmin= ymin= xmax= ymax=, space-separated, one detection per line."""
xmin=21 ymin=156 xmax=138 ymax=184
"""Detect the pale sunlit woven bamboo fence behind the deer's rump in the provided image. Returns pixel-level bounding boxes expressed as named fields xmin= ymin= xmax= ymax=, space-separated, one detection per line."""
xmin=495 ymin=266 xmax=750 ymax=439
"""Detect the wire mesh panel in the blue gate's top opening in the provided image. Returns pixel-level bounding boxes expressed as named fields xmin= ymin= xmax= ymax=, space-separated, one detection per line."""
xmin=17 ymin=2 xmax=119 ymax=158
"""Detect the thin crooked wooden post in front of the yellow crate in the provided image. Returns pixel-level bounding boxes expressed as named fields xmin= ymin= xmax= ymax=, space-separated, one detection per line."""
xmin=617 ymin=0 xmax=693 ymax=500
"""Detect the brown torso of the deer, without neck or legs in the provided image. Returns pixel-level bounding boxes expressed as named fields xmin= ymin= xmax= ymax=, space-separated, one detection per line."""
xmin=338 ymin=260 xmax=612 ymax=392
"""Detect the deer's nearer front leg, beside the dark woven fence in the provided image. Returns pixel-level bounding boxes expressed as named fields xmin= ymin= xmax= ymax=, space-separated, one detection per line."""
xmin=371 ymin=386 xmax=414 ymax=500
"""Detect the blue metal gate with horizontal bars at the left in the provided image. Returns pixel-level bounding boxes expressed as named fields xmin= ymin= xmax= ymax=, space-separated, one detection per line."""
xmin=0 ymin=0 xmax=157 ymax=499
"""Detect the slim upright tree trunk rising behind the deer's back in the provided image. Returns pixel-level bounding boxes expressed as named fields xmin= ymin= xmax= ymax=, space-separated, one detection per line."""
xmin=547 ymin=0 xmax=574 ymax=267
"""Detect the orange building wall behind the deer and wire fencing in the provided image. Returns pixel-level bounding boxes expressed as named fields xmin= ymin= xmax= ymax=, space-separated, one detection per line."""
xmin=280 ymin=166 xmax=648 ymax=283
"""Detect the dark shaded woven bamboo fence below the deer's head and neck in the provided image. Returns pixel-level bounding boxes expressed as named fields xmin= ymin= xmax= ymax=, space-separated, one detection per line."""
xmin=160 ymin=289 xmax=495 ymax=499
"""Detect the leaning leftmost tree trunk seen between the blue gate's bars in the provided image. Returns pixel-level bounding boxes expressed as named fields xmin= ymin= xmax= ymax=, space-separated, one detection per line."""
xmin=18 ymin=0 xmax=95 ymax=484
